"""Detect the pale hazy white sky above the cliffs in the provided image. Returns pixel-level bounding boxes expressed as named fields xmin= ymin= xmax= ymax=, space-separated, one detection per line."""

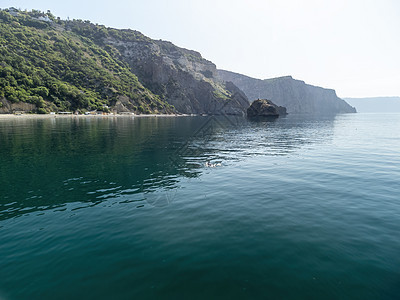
xmin=0 ymin=0 xmax=400 ymax=97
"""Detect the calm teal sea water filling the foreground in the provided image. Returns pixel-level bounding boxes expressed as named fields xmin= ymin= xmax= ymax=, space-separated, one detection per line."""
xmin=0 ymin=114 xmax=400 ymax=300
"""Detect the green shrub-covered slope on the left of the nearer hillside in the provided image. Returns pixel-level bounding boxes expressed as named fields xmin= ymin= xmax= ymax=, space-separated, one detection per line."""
xmin=0 ymin=10 xmax=174 ymax=113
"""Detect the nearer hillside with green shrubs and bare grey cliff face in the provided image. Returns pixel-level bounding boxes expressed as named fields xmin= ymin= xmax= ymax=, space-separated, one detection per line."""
xmin=0 ymin=9 xmax=249 ymax=115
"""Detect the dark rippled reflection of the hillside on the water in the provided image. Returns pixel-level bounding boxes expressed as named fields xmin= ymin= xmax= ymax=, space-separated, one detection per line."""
xmin=0 ymin=116 xmax=334 ymax=220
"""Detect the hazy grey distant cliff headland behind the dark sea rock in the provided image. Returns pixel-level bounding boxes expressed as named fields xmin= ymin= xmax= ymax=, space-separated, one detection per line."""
xmin=218 ymin=70 xmax=356 ymax=114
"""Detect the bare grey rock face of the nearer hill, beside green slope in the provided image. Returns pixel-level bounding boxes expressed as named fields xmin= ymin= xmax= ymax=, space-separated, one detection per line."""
xmin=105 ymin=33 xmax=249 ymax=115
